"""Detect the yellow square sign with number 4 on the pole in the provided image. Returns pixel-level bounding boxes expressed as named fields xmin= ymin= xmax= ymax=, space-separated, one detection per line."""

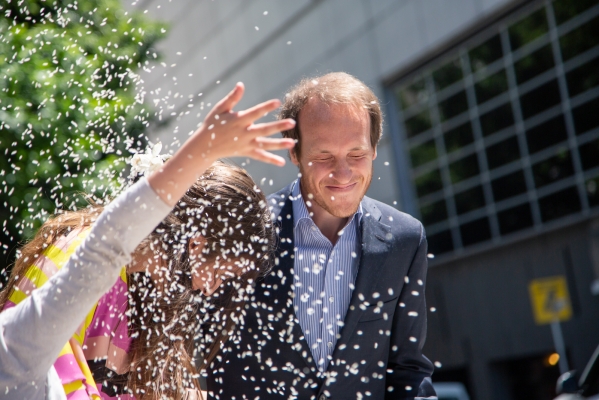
xmin=528 ymin=276 xmax=572 ymax=325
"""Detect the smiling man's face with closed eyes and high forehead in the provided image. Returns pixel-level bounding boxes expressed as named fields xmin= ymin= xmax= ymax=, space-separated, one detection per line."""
xmin=291 ymin=100 xmax=376 ymax=218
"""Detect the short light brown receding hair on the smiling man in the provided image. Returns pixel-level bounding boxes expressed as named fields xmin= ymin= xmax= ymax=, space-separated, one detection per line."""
xmin=278 ymin=72 xmax=383 ymax=155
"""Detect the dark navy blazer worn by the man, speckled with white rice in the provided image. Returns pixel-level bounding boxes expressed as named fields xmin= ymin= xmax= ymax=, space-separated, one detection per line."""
xmin=207 ymin=187 xmax=434 ymax=400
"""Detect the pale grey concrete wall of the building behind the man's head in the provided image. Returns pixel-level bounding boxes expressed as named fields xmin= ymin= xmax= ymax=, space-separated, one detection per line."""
xmin=132 ymin=0 xmax=509 ymax=204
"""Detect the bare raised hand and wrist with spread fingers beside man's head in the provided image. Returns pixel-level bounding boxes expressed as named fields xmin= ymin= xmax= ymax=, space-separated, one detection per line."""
xmin=148 ymin=83 xmax=295 ymax=205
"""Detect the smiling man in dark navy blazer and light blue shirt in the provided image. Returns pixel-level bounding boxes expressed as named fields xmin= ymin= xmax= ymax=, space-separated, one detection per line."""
xmin=207 ymin=73 xmax=436 ymax=400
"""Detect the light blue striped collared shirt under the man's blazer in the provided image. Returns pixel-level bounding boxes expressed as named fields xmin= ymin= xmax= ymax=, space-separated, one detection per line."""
xmin=291 ymin=180 xmax=362 ymax=372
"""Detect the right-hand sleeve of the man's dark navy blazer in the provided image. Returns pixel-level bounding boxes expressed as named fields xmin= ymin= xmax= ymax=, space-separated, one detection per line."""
xmin=385 ymin=225 xmax=435 ymax=400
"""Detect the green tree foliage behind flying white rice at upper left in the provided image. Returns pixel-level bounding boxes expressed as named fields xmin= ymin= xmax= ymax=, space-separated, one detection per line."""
xmin=0 ymin=0 xmax=166 ymax=269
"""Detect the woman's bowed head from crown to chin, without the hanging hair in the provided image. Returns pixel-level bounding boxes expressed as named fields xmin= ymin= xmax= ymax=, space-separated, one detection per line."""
xmin=180 ymin=163 xmax=275 ymax=295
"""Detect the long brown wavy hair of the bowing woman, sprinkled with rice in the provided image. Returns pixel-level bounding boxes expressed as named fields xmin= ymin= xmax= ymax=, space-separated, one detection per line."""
xmin=0 ymin=162 xmax=275 ymax=399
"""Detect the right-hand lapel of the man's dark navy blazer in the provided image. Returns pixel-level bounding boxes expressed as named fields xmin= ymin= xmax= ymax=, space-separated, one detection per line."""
xmin=331 ymin=197 xmax=391 ymax=350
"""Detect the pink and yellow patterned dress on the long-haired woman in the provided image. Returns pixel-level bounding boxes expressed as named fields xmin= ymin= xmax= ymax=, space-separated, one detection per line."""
xmin=4 ymin=229 xmax=135 ymax=400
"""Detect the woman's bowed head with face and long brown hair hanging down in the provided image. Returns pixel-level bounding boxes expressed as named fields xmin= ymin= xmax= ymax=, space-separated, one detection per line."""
xmin=130 ymin=162 xmax=275 ymax=397
